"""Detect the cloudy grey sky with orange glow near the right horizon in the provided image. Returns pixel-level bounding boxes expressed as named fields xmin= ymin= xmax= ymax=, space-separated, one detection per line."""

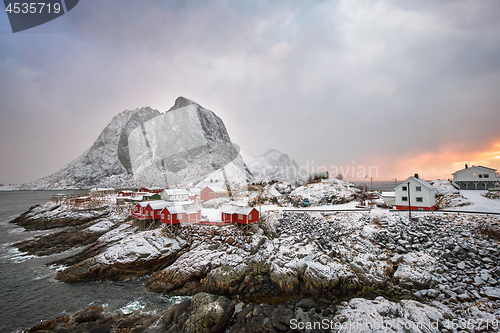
xmin=0 ymin=0 xmax=500 ymax=184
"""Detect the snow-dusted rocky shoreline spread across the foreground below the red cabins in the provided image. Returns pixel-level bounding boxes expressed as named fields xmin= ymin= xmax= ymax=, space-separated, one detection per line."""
xmin=12 ymin=198 xmax=500 ymax=332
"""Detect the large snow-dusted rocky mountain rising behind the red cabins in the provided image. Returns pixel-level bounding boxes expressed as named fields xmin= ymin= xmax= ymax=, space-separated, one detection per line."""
xmin=21 ymin=97 xmax=253 ymax=189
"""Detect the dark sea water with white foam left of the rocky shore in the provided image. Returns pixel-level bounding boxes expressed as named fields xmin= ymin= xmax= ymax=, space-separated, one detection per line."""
xmin=0 ymin=191 xmax=180 ymax=332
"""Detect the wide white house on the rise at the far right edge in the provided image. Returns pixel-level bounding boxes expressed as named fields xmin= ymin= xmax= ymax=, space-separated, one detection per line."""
xmin=453 ymin=164 xmax=500 ymax=190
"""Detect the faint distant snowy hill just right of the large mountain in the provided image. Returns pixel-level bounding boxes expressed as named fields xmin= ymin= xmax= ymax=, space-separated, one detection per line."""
xmin=243 ymin=149 xmax=309 ymax=183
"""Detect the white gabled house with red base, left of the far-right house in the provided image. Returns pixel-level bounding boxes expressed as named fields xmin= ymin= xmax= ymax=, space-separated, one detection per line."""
xmin=394 ymin=174 xmax=436 ymax=210
